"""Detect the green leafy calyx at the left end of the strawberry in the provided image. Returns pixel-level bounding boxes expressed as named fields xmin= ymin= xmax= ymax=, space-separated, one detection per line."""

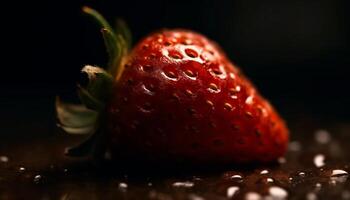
xmin=56 ymin=6 xmax=131 ymax=156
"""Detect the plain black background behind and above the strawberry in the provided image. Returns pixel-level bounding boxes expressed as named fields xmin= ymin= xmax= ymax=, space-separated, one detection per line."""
xmin=0 ymin=0 xmax=350 ymax=135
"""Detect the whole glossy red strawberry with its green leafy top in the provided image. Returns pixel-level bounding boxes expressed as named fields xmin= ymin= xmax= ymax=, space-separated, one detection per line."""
xmin=57 ymin=8 xmax=288 ymax=164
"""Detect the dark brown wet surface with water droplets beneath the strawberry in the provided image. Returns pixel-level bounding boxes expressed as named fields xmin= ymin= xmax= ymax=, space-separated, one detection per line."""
xmin=0 ymin=115 xmax=350 ymax=200
